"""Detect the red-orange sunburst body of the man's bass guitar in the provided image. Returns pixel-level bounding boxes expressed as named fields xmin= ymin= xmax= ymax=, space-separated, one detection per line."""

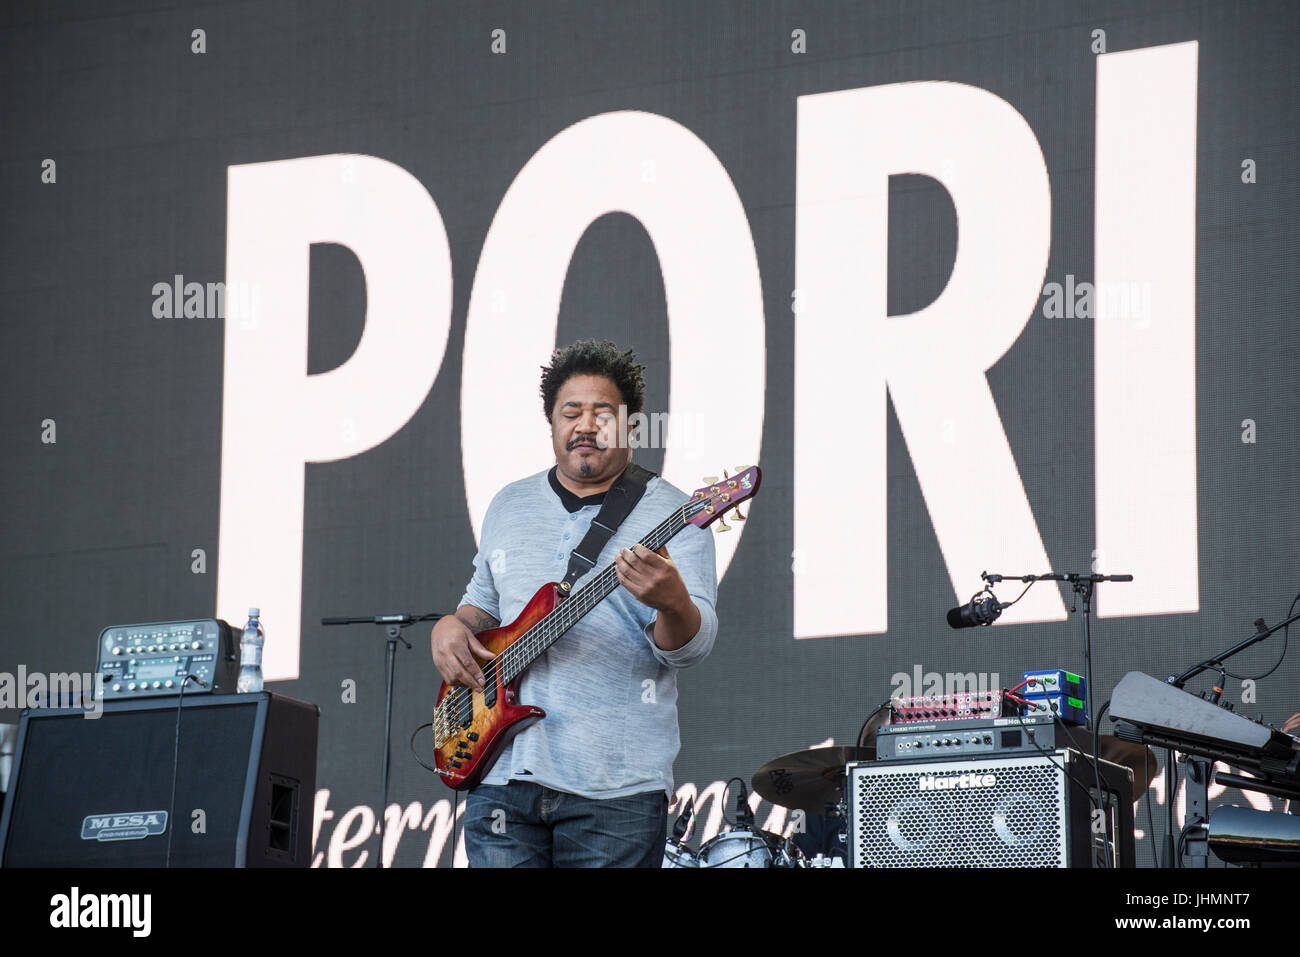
xmin=434 ymin=583 xmax=562 ymax=791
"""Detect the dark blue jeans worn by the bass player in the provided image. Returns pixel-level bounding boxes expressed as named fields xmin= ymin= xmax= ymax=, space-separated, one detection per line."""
xmin=464 ymin=781 xmax=668 ymax=867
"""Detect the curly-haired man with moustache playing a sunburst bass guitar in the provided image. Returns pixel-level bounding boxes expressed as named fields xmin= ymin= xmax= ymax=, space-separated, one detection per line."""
xmin=430 ymin=341 xmax=718 ymax=867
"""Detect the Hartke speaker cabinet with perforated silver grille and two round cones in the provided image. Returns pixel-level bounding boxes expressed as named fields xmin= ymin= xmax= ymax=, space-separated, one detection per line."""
xmin=848 ymin=749 xmax=1134 ymax=867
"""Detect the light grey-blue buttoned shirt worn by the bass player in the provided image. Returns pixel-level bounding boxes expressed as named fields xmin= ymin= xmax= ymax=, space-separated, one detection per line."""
xmin=460 ymin=472 xmax=718 ymax=798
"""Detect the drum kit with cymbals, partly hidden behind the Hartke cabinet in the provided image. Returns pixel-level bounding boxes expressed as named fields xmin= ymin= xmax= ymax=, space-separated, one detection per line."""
xmin=663 ymin=711 xmax=1153 ymax=869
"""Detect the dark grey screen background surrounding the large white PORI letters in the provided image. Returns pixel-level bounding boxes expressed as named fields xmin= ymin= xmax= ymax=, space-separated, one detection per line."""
xmin=0 ymin=1 xmax=1300 ymax=863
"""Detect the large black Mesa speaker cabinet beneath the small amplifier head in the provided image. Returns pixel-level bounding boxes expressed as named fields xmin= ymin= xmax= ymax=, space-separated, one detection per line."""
xmin=0 ymin=692 xmax=320 ymax=867
